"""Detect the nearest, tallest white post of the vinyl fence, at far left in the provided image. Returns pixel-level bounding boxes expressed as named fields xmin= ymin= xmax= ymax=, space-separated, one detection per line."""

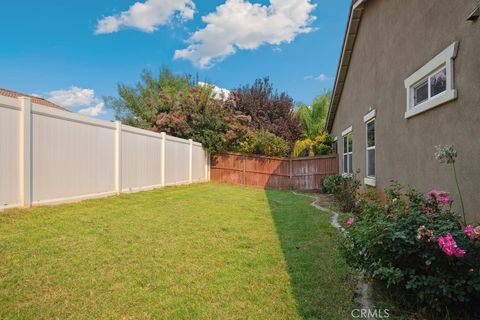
xmin=18 ymin=97 xmax=32 ymax=208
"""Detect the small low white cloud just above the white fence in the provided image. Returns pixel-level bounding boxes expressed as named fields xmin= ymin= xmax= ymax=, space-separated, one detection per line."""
xmin=46 ymin=86 xmax=105 ymax=117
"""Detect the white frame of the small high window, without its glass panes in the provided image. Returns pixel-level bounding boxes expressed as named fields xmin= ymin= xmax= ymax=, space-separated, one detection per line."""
xmin=405 ymin=42 xmax=458 ymax=119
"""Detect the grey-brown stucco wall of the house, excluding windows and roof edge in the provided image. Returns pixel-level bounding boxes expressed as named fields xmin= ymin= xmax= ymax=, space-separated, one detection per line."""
xmin=332 ymin=0 xmax=480 ymax=222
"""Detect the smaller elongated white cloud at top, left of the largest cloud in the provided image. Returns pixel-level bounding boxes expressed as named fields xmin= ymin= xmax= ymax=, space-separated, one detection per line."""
xmin=95 ymin=0 xmax=195 ymax=34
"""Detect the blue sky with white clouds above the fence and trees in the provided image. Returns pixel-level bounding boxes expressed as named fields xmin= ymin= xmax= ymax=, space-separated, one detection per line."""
xmin=0 ymin=0 xmax=350 ymax=119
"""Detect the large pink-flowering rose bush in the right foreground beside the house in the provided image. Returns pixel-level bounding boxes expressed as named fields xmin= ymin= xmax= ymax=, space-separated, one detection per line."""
xmin=342 ymin=185 xmax=480 ymax=313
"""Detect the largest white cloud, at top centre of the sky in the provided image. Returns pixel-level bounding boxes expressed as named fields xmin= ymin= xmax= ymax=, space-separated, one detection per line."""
xmin=174 ymin=0 xmax=316 ymax=68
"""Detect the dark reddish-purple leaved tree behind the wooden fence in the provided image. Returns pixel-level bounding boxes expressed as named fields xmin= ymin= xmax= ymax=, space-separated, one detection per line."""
xmin=230 ymin=78 xmax=302 ymax=146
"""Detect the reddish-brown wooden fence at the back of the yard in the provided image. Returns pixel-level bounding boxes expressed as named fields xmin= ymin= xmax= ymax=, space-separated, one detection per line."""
xmin=210 ymin=153 xmax=338 ymax=190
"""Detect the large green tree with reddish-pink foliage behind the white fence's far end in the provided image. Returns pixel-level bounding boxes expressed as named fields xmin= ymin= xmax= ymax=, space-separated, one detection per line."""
xmin=107 ymin=67 xmax=250 ymax=153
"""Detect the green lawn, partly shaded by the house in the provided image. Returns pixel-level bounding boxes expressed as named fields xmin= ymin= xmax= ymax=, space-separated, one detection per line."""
xmin=0 ymin=183 xmax=353 ymax=319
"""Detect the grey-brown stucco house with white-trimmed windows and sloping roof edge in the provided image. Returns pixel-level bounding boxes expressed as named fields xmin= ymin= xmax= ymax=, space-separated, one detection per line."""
xmin=327 ymin=0 xmax=480 ymax=222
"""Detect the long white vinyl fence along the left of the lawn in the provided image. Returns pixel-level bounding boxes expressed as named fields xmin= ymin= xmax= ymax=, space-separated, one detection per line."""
xmin=0 ymin=96 xmax=209 ymax=210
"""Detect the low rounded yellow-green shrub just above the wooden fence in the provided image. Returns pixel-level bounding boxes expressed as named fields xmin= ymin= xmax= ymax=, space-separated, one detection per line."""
xmin=236 ymin=131 xmax=290 ymax=157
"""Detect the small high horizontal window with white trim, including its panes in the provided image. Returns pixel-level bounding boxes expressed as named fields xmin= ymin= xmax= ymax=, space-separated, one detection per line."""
xmin=405 ymin=42 xmax=458 ymax=118
